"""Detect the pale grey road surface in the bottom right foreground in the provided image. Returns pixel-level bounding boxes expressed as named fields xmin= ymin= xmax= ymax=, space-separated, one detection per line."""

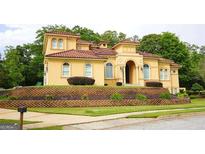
xmin=64 ymin=113 xmax=205 ymax=130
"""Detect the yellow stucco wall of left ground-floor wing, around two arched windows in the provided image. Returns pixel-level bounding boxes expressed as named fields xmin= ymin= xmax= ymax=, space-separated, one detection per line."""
xmin=45 ymin=58 xmax=104 ymax=85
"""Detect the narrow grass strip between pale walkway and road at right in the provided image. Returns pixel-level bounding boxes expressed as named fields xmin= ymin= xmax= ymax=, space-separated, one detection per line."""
xmin=127 ymin=108 xmax=205 ymax=118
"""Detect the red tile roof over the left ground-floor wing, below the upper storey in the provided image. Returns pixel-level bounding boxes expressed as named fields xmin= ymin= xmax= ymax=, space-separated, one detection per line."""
xmin=46 ymin=49 xmax=105 ymax=59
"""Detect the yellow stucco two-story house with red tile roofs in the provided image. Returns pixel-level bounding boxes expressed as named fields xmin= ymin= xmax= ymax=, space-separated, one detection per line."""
xmin=43 ymin=32 xmax=180 ymax=93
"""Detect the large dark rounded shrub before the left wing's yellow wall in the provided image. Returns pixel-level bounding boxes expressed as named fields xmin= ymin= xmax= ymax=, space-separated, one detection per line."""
xmin=67 ymin=76 xmax=95 ymax=85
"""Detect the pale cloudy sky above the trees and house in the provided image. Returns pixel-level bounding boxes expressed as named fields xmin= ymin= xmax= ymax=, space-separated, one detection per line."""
xmin=0 ymin=24 xmax=205 ymax=53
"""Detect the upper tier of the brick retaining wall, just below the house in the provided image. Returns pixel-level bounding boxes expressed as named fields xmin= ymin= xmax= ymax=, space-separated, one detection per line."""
xmin=6 ymin=86 xmax=169 ymax=100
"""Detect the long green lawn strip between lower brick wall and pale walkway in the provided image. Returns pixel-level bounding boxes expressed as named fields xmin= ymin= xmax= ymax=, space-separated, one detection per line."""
xmin=28 ymin=99 xmax=205 ymax=116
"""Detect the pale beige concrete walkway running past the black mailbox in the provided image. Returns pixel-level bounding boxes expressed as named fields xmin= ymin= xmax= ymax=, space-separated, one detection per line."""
xmin=0 ymin=108 xmax=205 ymax=129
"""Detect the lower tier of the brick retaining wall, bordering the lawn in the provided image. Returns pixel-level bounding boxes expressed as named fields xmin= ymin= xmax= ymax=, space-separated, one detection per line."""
xmin=0 ymin=99 xmax=190 ymax=108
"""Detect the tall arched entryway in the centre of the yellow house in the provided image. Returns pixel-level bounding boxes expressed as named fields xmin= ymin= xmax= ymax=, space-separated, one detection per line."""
xmin=125 ymin=60 xmax=136 ymax=84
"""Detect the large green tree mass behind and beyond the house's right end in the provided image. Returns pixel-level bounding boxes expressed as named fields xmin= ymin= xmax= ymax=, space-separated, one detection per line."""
xmin=139 ymin=32 xmax=205 ymax=89
